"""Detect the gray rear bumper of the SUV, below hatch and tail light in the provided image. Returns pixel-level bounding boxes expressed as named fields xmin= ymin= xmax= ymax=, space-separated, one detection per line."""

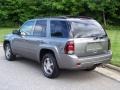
xmin=59 ymin=51 xmax=112 ymax=69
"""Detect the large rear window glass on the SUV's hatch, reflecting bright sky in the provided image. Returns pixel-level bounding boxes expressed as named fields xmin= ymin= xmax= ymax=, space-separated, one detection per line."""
xmin=70 ymin=20 xmax=106 ymax=38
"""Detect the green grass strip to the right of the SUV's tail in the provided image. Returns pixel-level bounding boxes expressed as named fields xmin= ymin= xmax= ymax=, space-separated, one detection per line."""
xmin=107 ymin=26 xmax=120 ymax=66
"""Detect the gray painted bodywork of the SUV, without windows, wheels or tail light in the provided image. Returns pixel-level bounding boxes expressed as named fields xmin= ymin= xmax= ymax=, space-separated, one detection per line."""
xmin=5 ymin=19 xmax=112 ymax=69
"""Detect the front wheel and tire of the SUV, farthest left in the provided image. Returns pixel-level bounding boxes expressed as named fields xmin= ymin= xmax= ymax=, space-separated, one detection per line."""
xmin=5 ymin=43 xmax=16 ymax=61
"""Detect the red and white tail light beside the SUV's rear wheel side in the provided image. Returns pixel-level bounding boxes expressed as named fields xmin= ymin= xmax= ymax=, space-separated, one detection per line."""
xmin=64 ymin=41 xmax=74 ymax=54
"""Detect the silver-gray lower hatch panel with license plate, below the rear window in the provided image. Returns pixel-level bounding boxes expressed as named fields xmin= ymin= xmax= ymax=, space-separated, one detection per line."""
xmin=74 ymin=38 xmax=108 ymax=57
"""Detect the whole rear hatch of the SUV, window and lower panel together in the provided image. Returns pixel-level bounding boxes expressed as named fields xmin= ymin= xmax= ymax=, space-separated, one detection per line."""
xmin=68 ymin=19 xmax=108 ymax=57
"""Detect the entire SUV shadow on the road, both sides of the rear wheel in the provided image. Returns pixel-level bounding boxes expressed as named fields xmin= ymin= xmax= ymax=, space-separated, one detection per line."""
xmin=16 ymin=57 xmax=100 ymax=82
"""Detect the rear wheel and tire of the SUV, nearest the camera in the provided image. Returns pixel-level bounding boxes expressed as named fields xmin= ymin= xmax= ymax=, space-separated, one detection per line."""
xmin=41 ymin=53 xmax=59 ymax=78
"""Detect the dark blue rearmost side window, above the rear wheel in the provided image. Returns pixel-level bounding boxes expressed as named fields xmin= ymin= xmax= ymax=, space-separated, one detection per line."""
xmin=50 ymin=20 xmax=69 ymax=38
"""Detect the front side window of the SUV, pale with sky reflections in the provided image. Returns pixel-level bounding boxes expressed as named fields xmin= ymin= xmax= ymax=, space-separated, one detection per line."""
xmin=20 ymin=21 xmax=34 ymax=35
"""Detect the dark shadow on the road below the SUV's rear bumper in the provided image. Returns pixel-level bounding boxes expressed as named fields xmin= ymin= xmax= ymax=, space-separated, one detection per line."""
xmin=59 ymin=70 xmax=99 ymax=81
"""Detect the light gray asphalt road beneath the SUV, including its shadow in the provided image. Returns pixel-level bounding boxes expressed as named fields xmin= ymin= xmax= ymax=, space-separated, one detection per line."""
xmin=0 ymin=47 xmax=120 ymax=90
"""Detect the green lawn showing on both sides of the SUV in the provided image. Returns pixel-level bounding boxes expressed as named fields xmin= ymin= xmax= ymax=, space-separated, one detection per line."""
xmin=0 ymin=26 xmax=120 ymax=66
